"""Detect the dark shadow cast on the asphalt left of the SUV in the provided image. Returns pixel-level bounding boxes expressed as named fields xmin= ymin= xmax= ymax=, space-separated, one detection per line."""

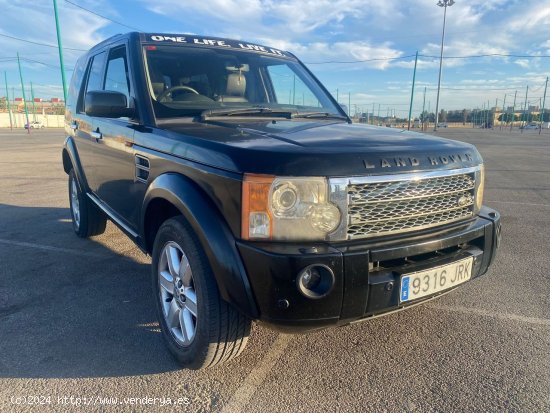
xmin=0 ymin=204 xmax=184 ymax=378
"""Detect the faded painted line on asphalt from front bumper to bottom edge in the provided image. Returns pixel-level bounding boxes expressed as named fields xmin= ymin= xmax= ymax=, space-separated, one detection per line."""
xmin=222 ymin=334 xmax=292 ymax=413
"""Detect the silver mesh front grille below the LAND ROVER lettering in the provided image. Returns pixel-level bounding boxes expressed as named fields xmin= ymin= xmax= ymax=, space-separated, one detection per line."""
xmin=331 ymin=168 xmax=479 ymax=239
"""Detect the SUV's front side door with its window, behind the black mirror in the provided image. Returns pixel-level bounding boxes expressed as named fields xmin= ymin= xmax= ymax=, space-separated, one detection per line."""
xmin=92 ymin=42 xmax=140 ymax=229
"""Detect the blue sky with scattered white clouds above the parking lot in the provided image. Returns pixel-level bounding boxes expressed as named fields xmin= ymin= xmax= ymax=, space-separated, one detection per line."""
xmin=0 ymin=0 xmax=550 ymax=117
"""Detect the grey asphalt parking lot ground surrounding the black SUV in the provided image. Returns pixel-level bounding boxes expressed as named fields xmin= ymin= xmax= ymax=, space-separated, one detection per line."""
xmin=0 ymin=129 xmax=550 ymax=413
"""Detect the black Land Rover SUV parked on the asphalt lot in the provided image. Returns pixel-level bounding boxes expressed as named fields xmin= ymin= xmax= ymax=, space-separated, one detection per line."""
xmin=63 ymin=33 xmax=500 ymax=368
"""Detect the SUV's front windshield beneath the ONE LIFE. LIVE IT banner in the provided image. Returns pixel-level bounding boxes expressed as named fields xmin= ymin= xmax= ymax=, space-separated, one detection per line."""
xmin=144 ymin=46 xmax=341 ymax=118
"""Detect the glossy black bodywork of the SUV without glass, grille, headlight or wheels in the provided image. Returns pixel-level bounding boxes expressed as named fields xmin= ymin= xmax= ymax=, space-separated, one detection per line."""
xmin=63 ymin=33 xmax=500 ymax=331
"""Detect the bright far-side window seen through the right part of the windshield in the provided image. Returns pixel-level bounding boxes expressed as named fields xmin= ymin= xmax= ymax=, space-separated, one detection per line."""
xmin=267 ymin=64 xmax=319 ymax=106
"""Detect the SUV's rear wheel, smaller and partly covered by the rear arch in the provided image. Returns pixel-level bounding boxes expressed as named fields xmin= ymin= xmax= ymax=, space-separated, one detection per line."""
xmin=69 ymin=169 xmax=107 ymax=238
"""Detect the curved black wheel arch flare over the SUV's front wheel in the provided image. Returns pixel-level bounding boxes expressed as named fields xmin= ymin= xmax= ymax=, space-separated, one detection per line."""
xmin=140 ymin=173 xmax=259 ymax=318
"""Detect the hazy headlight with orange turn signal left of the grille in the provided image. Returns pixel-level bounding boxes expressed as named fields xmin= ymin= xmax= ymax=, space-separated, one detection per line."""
xmin=242 ymin=175 xmax=341 ymax=240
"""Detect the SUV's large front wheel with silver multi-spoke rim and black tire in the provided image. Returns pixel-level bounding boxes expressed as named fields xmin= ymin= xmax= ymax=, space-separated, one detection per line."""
xmin=151 ymin=216 xmax=251 ymax=370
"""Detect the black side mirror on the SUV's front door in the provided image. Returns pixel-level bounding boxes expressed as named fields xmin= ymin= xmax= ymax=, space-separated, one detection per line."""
xmin=84 ymin=90 xmax=135 ymax=118
